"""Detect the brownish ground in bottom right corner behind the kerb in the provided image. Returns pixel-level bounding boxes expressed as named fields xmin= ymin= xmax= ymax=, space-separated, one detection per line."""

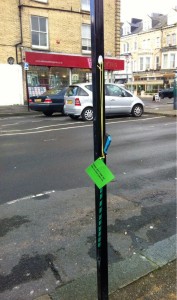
xmin=35 ymin=260 xmax=177 ymax=300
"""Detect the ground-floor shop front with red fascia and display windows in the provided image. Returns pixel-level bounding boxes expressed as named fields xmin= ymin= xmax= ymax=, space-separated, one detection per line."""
xmin=25 ymin=51 xmax=124 ymax=96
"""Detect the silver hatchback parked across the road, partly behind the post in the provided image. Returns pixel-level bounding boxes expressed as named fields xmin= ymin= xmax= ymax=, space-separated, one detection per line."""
xmin=64 ymin=83 xmax=144 ymax=121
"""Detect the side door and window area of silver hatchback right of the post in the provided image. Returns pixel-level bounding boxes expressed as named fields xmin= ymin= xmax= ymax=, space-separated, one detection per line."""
xmin=106 ymin=84 xmax=134 ymax=114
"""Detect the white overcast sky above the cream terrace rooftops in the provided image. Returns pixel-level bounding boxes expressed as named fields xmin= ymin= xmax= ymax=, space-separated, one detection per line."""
xmin=121 ymin=0 xmax=177 ymax=22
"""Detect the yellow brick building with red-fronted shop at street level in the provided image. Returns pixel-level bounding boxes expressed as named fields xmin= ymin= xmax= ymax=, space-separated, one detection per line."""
xmin=0 ymin=0 xmax=123 ymax=103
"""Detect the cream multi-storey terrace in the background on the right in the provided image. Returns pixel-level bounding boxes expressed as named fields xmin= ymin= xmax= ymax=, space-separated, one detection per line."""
xmin=116 ymin=9 xmax=177 ymax=94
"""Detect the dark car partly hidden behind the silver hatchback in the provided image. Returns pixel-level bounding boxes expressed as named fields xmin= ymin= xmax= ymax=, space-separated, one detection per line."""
xmin=29 ymin=87 xmax=68 ymax=117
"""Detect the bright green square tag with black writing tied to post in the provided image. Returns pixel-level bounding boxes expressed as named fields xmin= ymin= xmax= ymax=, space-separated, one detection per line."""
xmin=85 ymin=157 xmax=115 ymax=189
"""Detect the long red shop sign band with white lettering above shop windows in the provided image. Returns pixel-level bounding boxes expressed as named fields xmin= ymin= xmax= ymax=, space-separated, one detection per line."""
xmin=25 ymin=52 xmax=124 ymax=71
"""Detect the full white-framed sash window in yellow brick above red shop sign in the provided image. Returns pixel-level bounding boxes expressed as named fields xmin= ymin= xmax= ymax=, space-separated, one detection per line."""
xmin=31 ymin=16 xmax=48 ymax=49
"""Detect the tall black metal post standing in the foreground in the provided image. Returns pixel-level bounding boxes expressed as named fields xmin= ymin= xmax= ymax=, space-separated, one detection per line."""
xmin=90 ymin=0 xmax=108 ymax=300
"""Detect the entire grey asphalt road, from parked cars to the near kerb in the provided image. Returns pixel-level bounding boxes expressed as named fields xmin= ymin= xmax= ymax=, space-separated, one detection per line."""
xmin=0 ymin=115 xmax=177 ymax=300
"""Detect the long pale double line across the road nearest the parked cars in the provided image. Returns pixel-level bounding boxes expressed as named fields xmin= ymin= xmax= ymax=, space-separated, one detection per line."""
xmin=0 ymin=116 xmax=166 ymax=136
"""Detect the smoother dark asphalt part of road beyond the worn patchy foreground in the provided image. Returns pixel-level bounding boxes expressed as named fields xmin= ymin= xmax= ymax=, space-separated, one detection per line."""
xmin=0 ymin=112 xmax=176 ymax=203
